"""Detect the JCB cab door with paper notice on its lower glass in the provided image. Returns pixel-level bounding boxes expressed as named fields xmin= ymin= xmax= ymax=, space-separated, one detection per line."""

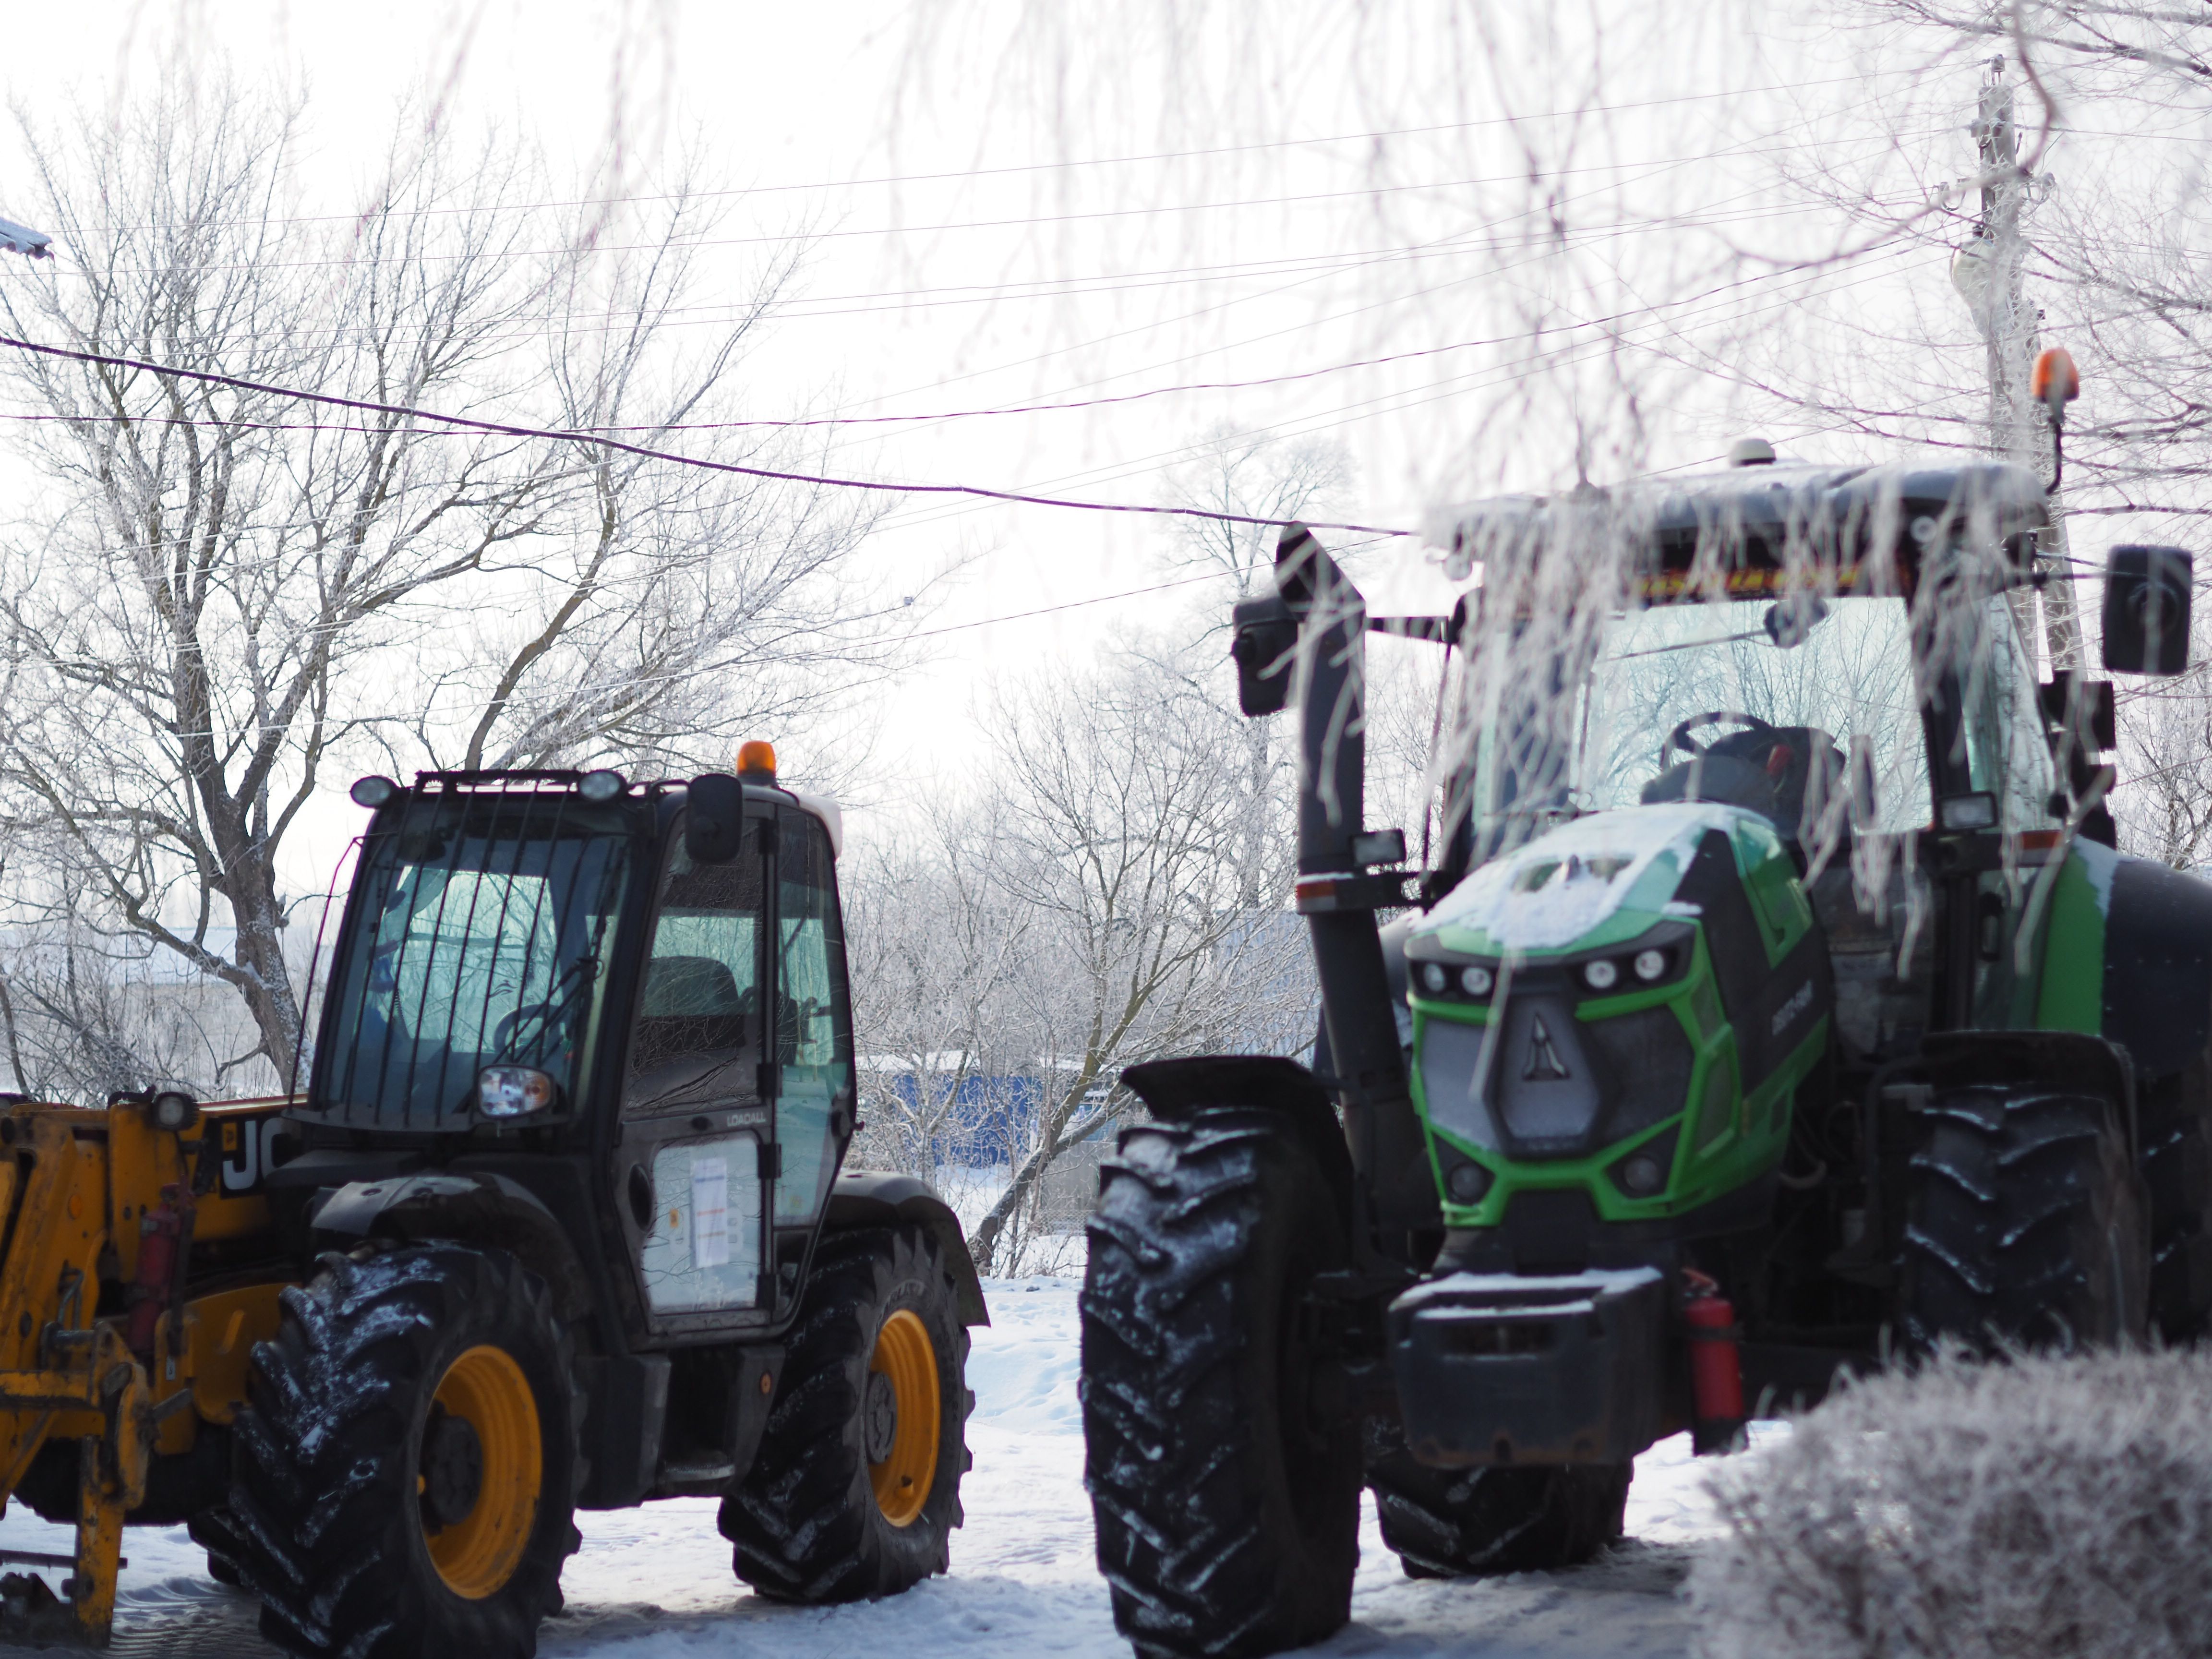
xmin=615 ymin=816 xmax=774 ymax=1329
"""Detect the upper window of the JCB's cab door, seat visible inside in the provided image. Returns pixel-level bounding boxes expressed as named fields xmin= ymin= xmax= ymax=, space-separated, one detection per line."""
xmin=622 ymin=838 xmax=761 ymax=1117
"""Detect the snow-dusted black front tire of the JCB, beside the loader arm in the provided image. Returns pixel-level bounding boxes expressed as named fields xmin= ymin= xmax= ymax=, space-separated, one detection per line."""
xmin=230 ymin=1243 xmax=584 ymax=1659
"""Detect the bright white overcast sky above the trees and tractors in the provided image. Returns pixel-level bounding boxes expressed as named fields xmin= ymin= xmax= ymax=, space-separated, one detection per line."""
xmin=0 ymin=0 xmax=2185 ymax=898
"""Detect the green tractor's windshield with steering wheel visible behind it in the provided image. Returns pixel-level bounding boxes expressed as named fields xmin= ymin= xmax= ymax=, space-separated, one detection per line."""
xmin=1573 ymin=595 xmax=1929 ymax=836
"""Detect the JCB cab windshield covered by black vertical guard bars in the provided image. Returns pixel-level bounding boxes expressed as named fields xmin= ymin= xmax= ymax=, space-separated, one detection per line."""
xmin=310 ymin=794 xmax=630 ymax=1128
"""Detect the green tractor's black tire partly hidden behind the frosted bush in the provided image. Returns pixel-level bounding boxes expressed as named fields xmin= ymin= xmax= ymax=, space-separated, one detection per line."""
xmin=1898 ymin=1084 xmax=2150 ymax=1351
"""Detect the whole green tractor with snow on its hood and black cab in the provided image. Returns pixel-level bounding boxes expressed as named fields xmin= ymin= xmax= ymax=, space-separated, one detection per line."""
xmin=1082 ymin=447 xmax=2212 ymax=1655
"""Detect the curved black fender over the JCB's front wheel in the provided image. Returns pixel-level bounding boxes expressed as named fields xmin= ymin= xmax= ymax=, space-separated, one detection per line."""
xmin=308 ymin=1172 xmax=595 ymax=1321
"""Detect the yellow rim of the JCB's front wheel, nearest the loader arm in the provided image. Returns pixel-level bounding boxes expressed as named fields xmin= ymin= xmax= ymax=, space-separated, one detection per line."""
xmin=416 ymin=1345 xmax=544 ymax=1601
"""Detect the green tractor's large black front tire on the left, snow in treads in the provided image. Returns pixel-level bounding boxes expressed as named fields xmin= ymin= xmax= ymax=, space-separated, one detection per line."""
xmin=1082 ymin=1108 xmax=1360 ymax=1659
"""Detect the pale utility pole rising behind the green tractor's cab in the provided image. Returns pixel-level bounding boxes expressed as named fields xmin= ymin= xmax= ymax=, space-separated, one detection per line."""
xmin=1951 ymin=55 xmax=2081 ymax=668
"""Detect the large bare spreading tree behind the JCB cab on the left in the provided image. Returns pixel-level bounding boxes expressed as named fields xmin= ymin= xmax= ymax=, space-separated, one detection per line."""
xmin=0 ymin=82 xmax=907 ymax=1093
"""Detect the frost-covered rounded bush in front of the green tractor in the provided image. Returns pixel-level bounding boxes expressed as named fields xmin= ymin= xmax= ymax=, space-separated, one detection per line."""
xmin=1688 ymin=1351 xmax=2212 ymax=1659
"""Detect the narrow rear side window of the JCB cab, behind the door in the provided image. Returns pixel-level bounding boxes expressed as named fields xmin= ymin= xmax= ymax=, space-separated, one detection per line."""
xmin=776 ymin=812 xmax=852 ymax=1223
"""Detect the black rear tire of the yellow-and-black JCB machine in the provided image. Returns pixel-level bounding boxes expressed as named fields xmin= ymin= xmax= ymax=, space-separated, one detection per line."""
xmin=721 ymin=1226 xmax=975 ymax=1604
